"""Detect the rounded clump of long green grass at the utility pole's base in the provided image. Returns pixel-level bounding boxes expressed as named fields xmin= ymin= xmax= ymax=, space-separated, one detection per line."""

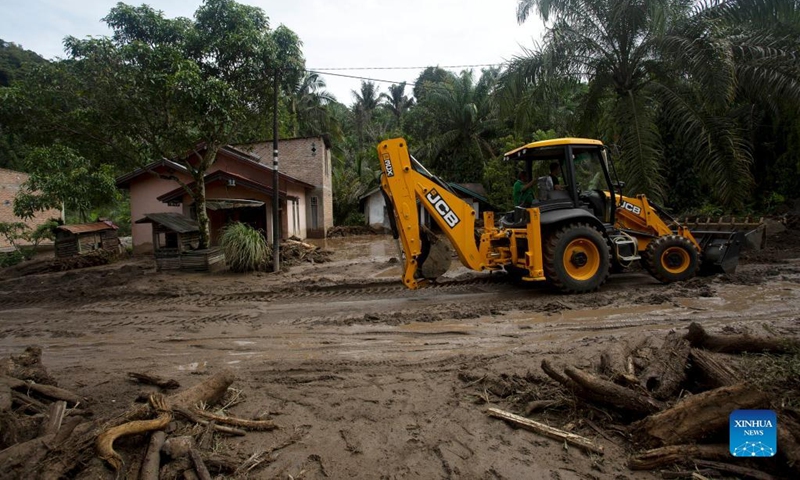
xmin=221 ymin=222 xmax=272 ymax=273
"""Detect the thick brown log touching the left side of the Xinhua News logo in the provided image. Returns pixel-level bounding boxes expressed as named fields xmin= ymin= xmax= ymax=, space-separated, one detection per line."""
xmin=631 ymin=384 xmax=769 ymax=447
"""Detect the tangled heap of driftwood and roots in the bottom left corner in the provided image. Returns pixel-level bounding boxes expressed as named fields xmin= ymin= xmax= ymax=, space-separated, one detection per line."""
xmin=0 ymin=347 xmax=298 ymax=480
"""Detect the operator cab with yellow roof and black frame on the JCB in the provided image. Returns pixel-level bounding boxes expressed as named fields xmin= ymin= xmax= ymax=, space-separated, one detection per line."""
xmin=504 ymin=138 xmax=614 ymax=225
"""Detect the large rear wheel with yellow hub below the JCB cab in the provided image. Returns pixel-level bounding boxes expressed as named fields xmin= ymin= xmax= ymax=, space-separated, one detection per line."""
xmin=543 ymin=223 xmax=611 ymax=293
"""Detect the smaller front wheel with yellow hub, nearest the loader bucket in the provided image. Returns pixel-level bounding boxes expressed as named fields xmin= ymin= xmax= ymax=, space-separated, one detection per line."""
xmin=642 ymin=235 xmax=700 ymax=283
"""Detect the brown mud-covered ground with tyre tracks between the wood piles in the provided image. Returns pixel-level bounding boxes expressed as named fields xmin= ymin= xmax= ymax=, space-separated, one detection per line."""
xmin=0 ymin=232 xmax=800 ymax=479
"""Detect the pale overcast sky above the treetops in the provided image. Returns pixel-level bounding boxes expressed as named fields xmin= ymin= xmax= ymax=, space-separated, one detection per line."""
xmin=0 ymin=0 xmax=543 ymax=105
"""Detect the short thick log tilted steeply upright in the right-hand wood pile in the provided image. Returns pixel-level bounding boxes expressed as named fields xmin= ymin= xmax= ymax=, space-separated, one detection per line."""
xmin=639 ymin=332 xmax=690 ymax=400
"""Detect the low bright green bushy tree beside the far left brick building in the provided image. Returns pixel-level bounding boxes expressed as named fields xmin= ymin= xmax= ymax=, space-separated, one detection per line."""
xmin=14 ymin=145 xmax=119 ymax=218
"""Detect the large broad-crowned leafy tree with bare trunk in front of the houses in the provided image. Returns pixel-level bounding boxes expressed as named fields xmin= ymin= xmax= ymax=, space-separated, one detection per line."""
xmin=5 ymin=0 xmax=304 ymax=248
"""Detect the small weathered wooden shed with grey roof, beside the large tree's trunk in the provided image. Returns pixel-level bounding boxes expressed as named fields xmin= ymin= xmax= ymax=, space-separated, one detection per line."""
xmin=136 ymin=212 xmax=225 ymax=271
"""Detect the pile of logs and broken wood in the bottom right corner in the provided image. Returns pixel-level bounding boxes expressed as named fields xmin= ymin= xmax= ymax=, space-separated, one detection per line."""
xmin=468 ymin=323 xmax=800 ymax=480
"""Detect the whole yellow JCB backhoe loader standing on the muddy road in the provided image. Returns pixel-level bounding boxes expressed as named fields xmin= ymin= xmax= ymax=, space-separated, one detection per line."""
xmin=378 ymin=138 xmax=744 ymax=293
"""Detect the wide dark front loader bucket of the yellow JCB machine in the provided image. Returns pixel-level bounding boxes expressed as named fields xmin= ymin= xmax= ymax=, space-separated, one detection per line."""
xmin=683 ymin=217 xmax=766 ymax=275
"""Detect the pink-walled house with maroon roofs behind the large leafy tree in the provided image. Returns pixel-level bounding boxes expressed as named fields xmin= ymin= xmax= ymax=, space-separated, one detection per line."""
xmin=117 ymin=140 xmax=323 ymax=253
